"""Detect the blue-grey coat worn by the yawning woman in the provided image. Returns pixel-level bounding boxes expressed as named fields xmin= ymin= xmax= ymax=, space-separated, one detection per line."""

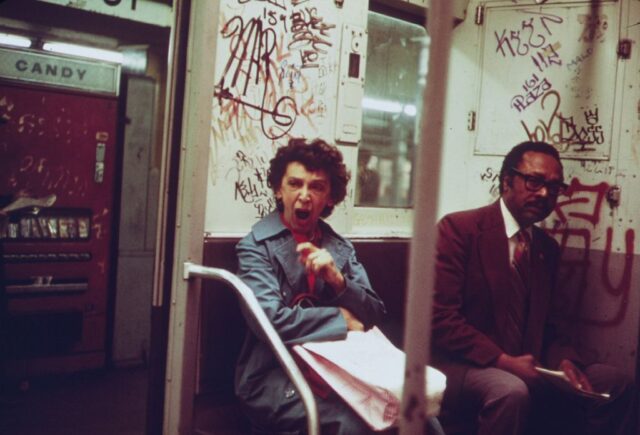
xmin=235 ymin=212 xmax=385 ymax=419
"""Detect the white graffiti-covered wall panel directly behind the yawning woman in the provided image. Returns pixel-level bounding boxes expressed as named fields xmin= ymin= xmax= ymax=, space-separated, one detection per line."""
xmin=205 ymin=0 xmax=368 ymax=234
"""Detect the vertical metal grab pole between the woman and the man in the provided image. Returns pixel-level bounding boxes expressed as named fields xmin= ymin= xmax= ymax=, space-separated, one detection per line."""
xmin=400 ymin=0 xmax=453 ymax=435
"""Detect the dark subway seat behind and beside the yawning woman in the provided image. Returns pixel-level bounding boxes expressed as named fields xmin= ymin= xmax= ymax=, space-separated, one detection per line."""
xmin=194 ymin=238 xmax=409 ymax=435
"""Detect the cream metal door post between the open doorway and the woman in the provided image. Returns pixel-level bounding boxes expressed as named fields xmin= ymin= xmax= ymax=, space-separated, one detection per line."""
xmin=163 ymin=0 xmax=220 ymax=435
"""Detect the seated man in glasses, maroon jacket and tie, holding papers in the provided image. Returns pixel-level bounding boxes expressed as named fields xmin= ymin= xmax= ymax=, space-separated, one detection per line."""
xmin=432 ymin=142 xmax=635 ymax=435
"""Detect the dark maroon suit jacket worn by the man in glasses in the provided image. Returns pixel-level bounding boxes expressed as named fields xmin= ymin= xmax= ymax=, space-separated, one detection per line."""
xmin=432 ymin=201 xmax=579 ymax=406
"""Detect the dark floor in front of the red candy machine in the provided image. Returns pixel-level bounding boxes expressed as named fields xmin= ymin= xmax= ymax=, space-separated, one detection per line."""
xmin=0 ymin=368 xmax=148 ymax=435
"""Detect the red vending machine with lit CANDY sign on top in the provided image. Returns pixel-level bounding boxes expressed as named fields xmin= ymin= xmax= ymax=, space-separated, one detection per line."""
xmin=0 ymin=49 xmax=120 ymax=377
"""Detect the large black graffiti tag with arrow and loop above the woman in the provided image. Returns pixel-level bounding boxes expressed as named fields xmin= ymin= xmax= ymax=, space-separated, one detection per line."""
xmin=214 ymin=16 xmax=297 ymax=140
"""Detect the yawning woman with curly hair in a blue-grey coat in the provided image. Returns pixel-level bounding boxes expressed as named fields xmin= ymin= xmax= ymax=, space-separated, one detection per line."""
xmin=235 ymin=139 xmax=385 ymax=434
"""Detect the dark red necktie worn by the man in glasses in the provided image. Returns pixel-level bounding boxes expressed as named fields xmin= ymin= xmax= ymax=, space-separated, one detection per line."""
xmin=504 ymin=230 xmax=530 ymax=355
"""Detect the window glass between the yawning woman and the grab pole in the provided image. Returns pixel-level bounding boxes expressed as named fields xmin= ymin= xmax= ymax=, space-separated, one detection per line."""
xmin=355 ymin=12 xmax=428 ymax=208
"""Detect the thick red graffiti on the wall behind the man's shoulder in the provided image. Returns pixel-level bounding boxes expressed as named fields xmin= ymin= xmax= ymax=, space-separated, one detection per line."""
xmin=548 ymin=178 xmax=635 ymax=326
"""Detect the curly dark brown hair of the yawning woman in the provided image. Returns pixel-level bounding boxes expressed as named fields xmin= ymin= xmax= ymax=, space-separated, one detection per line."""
xmin=267 ymin=138 xmax=351 ymax=218
